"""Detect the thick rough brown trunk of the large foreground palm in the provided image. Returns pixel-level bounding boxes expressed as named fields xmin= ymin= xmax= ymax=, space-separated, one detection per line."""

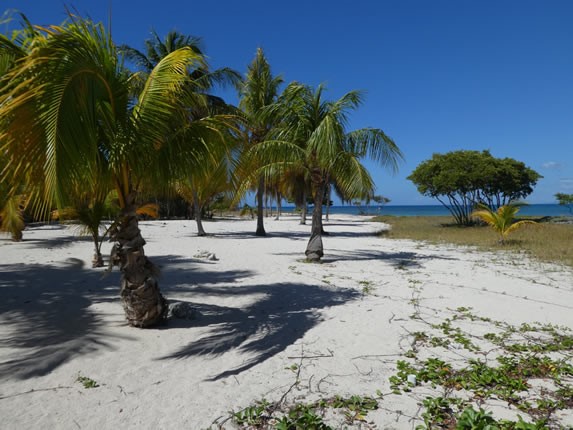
xmin=111 ymin=205 xmax=167 ymax=327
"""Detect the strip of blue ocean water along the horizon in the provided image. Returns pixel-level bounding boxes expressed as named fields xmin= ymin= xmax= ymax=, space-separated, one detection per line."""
xmin=283 ymin=204 xmax=571 ymax=216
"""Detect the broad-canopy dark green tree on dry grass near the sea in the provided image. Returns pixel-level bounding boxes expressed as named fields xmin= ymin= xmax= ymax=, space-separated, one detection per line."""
xmin=407 ymin=150 xmax=542 ymax=225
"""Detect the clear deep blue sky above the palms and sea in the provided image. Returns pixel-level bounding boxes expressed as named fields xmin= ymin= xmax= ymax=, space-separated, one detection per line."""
xmin=1 ymin=0 xmax=573 ymax=204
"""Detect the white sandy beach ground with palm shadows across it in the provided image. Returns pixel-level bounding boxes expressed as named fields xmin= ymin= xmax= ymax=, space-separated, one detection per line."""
xmin=0 ymin=216 xmax=573 ymax=429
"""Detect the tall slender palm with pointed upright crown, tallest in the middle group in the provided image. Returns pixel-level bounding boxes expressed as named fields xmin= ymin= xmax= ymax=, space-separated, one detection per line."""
xmin=239 ymin=48 xmax=283 ymax=236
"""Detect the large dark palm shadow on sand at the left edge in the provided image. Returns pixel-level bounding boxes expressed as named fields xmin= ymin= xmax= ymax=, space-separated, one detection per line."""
xmin=0 ymin=264 xmax=130 ymax=379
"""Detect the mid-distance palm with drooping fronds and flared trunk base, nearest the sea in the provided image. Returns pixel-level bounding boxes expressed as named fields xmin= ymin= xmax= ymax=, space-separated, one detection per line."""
xmin=257 ymin=83 xmax=402 ymax=261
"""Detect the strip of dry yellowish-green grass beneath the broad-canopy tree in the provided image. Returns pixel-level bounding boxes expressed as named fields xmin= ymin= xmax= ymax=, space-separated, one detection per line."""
xmin=374 ymin=216 xmax=573 ymax=267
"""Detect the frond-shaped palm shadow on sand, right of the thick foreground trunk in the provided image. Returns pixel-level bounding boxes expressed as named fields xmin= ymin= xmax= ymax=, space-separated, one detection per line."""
xmin=161 ymin=283 xmax=361 ymax=381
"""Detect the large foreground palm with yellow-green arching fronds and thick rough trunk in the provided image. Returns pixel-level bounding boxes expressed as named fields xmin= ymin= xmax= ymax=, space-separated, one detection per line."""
xmin=0 ymin=18 xmax=219 ymax=327
